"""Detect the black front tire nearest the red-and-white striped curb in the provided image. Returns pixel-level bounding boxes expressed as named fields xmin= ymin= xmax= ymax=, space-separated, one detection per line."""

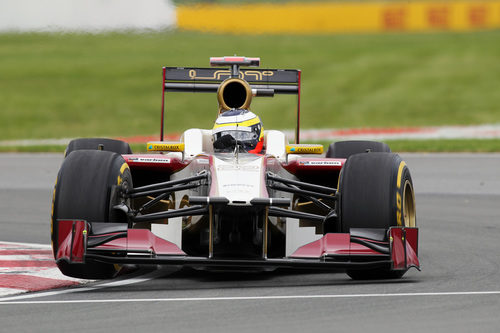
xmin=51 ymin=150 xmax=132 ymax=279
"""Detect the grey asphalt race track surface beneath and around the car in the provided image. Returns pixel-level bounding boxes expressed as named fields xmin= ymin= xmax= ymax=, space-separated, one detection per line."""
xmin=0 ymin=154 xmax=500 ymax=332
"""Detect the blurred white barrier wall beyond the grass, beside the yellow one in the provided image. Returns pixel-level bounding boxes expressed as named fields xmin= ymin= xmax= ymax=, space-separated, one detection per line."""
xmin=0 ymin=0 xmax=175 ymax=32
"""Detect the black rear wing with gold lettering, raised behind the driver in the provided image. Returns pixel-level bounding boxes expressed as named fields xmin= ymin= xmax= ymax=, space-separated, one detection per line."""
xmin=160 ymin=57 xmax=301 ymax=143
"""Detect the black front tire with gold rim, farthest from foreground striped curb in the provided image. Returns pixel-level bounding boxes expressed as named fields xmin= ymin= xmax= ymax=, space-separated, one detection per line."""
xmin=339 ymin=153 xmax=416 ymax=280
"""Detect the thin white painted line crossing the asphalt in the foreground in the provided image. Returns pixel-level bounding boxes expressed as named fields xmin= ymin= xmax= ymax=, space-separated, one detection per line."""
xmin=0 ymin=288 xmax=500 ymax=305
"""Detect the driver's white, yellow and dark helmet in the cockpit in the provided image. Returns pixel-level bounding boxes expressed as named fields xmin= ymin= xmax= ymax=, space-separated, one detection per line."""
xmin=212 ymin=109 xmax=264 ymax=154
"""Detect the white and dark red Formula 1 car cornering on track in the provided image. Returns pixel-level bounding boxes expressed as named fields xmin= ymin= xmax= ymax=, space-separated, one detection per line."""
xmin=51 ymin=56 xmax=419 ymax=279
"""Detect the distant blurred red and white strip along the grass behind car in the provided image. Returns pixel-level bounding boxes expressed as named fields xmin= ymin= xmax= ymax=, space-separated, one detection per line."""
xmin=0 ymin=124 xmax=500 ymax=147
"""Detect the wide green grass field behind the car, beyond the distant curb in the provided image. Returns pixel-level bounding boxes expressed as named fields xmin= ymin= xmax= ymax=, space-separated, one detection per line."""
xmin=0 ymin=31 xmax=500 ymax=150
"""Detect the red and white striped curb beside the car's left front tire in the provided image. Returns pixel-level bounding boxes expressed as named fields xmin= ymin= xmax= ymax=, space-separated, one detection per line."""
xmin=0 ymin=242 xmax=90 ymax=297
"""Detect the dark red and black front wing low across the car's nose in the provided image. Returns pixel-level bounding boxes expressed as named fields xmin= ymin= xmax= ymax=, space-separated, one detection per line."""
xmin=54 ymin=220 xmax=420 ymax=271
